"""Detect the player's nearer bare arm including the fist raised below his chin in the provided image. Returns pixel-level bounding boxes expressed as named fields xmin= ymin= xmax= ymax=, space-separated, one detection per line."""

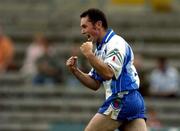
xmin=80 ymin=42 xmax=114 ymax=80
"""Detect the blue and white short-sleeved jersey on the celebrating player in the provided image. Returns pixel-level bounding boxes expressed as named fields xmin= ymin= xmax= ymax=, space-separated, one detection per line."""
xmin=89 ymin=29 xmax=139 ymax=99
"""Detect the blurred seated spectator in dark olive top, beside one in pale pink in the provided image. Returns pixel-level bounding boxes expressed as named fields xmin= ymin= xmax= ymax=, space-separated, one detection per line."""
xmin=33 ymin=36 xmax=64 ymax=85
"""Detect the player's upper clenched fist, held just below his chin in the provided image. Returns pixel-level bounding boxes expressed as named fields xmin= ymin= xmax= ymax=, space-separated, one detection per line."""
xmin=80 ymin=42 xmax=93 ymax=57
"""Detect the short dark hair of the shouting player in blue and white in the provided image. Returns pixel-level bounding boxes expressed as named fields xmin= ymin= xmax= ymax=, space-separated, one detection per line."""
xmin=80 ymin=8 xmax=108 ymax=29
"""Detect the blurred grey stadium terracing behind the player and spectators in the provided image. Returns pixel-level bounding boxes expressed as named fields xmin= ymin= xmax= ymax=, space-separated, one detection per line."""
xmin=0 ymin=0 xmax=180 ymax=131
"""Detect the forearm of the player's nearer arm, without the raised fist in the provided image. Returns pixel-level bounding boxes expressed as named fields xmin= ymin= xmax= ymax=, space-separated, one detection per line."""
xmin=87 ymin=54 xmax=114 ymax=80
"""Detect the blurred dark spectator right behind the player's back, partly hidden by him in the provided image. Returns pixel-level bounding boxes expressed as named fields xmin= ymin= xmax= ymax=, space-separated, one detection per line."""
xmin=134 ymin=54 xmax=149 ymax=96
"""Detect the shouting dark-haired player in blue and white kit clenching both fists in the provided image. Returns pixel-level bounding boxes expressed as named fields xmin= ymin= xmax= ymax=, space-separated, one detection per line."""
xmin=66 ymin=9 xmax=147 ymax=131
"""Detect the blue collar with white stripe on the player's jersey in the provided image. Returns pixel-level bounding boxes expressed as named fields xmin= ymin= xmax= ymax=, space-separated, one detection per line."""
xmin=96 ymin=29 xmax=115 ymax=50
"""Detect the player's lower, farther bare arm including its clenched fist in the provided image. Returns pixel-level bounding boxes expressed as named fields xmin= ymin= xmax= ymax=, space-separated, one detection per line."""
xmin=66 ymin=56 xmax=100 ymax=90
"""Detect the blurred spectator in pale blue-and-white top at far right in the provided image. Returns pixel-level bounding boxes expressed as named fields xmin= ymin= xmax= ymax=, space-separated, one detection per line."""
xmin=150 ymin=57 xmax=179 ymax=97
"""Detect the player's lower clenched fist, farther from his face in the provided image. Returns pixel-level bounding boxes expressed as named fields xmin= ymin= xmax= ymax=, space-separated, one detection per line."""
xmin=66 ymin=56 xmax=78 ymax=72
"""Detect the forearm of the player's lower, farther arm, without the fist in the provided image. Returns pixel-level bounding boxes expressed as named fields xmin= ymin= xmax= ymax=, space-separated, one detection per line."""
xmin=72 ymin=68 xmax=100 ymax=90
